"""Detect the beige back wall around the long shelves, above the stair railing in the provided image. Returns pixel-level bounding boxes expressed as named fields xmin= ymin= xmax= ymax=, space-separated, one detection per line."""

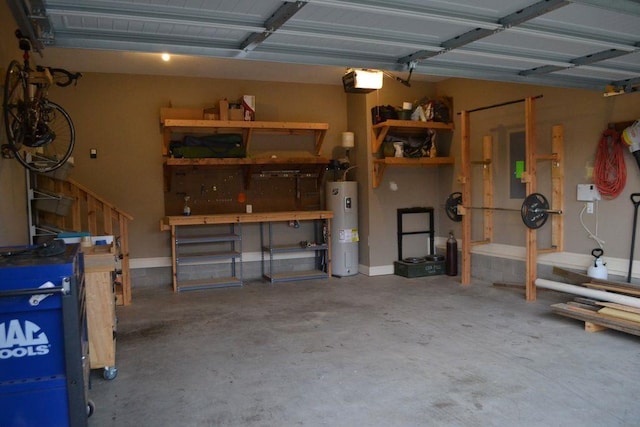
xmin=51 ymin=74 xmax=347 ymax=259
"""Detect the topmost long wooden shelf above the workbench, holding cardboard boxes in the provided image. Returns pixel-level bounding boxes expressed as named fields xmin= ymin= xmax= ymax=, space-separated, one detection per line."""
xmin=161 ymin=119 xmax=329 ymax=156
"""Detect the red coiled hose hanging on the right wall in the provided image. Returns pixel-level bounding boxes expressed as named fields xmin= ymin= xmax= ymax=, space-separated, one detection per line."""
xmin=593 ymin=129 xmax=627 ymax=199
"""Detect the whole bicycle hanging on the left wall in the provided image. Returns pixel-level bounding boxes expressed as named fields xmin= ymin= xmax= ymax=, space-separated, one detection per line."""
xmin=2 ymin=30 xmax=82 ymax=173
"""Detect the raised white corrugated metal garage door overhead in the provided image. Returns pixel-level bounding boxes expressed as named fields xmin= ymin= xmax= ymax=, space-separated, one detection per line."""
xmin=9 ymin=0 xmax=640 ymax=87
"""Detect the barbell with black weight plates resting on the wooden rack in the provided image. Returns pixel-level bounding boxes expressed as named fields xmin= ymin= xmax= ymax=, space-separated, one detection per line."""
xmin=445 ymin=191 xmax=562 ymax=229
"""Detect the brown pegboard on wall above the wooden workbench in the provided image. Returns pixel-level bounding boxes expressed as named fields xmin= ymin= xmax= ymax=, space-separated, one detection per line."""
xmin=164 ymin=167 xmax=324 ymax=215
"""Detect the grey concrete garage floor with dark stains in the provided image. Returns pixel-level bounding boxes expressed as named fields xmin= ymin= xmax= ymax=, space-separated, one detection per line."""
xmin=89 ymin=275 xmax=640 ymax=427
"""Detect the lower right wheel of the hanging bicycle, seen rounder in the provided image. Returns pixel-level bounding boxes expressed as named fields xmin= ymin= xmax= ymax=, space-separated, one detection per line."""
xmin=11 ymin=101 xmax=76 ymax=173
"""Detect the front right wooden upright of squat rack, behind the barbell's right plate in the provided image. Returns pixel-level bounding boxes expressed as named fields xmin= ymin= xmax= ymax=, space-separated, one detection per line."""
xmin=525 ymin=98 xmax=538 ymax=301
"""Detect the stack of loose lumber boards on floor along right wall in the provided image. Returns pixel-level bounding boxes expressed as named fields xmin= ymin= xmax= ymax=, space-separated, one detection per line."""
xmin=551 ymin=267 xmax=640 ymax=336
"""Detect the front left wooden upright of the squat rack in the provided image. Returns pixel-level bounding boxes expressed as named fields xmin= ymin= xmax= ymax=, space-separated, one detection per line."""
xmin=460 ymin=111 xmax=471 ymax=285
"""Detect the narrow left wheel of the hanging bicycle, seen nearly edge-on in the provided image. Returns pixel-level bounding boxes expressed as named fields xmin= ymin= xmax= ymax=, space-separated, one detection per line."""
xmin=2 ymin=61 xmax=27 ymax=154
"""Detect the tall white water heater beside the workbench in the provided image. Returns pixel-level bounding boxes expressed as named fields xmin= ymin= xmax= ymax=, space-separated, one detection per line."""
xmin=326 ymin=181 xmax=360 ymax=276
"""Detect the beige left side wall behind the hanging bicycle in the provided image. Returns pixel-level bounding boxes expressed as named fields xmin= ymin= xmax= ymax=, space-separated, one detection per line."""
xmin=0 ymin=2 xmax=29 ymax=246
